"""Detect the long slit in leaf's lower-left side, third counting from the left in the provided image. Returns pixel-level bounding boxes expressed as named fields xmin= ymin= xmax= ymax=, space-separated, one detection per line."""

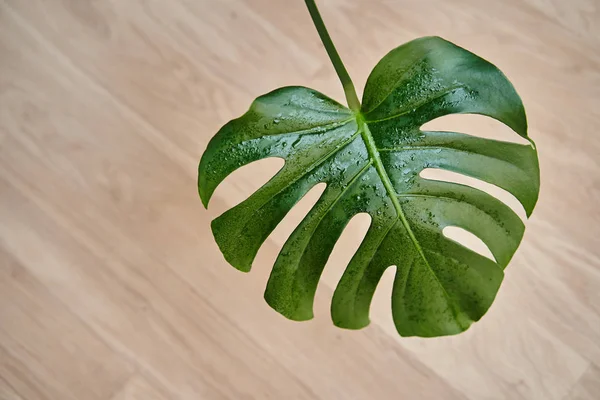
xmin=315 ymin=213 xmax=372 ymax=317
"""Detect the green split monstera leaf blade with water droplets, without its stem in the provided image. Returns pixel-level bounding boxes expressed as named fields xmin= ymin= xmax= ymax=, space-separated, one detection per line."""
xmin=198 ymin=37 xmax=539 ymax=337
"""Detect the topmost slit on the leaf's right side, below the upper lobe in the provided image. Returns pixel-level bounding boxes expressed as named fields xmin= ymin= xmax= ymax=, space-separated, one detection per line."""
xmin=421 ymin=114 xmax=530 ymax=145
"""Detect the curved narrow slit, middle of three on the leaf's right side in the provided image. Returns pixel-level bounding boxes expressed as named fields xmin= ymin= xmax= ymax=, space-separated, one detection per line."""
xmin=419 ymin=168 xmax=527 ymax=221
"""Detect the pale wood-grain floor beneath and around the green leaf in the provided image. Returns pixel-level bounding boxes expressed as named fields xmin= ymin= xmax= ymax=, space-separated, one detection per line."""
xmin=0 ymin=0 xmax=600 ymax=400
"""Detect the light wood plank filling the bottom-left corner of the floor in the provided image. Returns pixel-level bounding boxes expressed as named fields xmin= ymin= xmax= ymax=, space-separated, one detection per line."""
xmin=0 ymin=247 xmax=131 ymax=400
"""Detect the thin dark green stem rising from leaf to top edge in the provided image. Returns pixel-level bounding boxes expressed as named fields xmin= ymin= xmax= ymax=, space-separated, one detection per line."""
xmin=304 ymin=0 xmax=360 ymax=112
